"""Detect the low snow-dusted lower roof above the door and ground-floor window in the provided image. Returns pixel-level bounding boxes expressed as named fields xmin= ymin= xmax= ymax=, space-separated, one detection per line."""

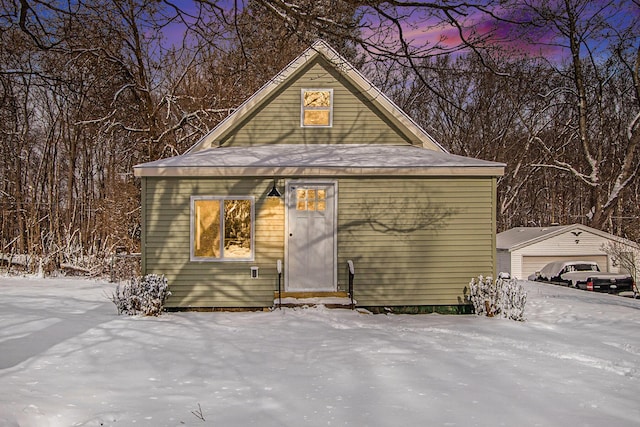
xmin=134 ymin=144 xmax=505 ymax=177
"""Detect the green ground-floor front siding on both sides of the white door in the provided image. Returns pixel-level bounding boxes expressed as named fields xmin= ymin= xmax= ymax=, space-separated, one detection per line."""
xmin=142 ymin=177 xmax=495 ymax=307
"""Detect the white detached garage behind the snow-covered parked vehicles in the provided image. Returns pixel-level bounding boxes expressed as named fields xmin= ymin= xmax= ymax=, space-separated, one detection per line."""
xmin=496 ymin=224 xmax=640 ymax=279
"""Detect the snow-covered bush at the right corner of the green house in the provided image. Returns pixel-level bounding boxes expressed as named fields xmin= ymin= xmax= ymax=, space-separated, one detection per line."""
xmin=469 ymin=276 xmax=527 ymax=321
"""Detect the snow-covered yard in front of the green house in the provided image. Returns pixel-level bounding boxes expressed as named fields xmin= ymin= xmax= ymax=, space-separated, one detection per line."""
xmin=0 ymin=277 xmax=640 ymax=427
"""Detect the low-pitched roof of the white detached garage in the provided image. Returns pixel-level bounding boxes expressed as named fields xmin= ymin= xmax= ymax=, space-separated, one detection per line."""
xmin=496 ymin=224 xmax=623 ymax=252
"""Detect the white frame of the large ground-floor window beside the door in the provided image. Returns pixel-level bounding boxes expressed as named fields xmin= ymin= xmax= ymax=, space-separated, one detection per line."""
xmin=189 ymin=196 xmax=256 ymax=262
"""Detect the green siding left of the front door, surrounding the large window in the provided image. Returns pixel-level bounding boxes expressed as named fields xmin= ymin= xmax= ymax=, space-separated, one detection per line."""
xmin=142 ymin=178 xmax=284 ymax=307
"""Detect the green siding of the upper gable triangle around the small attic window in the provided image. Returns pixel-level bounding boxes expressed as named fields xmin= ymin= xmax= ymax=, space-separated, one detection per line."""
xmin=218 ymin=59 xmax=412 ymax=146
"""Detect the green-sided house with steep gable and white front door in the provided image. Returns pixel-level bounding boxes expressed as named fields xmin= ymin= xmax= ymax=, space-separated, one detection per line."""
xmin=135 ymin=41 xmax=504 ymax=309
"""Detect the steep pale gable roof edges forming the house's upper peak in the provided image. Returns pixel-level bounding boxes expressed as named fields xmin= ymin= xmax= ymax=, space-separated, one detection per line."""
xmin=184 ymin=40 xmax=447 ymax=154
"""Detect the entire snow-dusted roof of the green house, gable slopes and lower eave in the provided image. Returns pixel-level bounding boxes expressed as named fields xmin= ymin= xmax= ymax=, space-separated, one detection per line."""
xmin=134 ymin=40 xmax=505 ymax=177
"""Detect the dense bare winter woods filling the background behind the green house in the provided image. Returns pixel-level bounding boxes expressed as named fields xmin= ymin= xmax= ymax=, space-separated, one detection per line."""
xmin=0 ymin=0 xmax=640 ymax=274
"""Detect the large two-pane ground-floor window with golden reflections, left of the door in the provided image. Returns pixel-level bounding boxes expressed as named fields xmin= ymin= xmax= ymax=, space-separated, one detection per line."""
xmin=191 ymin=196 xmax=254 ymax=261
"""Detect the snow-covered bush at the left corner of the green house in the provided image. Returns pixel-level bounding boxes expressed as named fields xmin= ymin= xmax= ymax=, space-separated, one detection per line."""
xmin=111 ymin=274 xmax=171 ymax=316
